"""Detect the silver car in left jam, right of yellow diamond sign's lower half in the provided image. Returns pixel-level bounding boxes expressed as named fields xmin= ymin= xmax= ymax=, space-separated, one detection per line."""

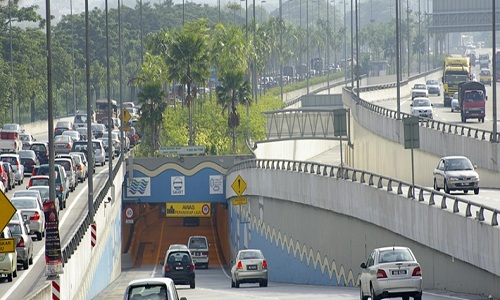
xmin=7 ymin=212 xmax=33 ymax=270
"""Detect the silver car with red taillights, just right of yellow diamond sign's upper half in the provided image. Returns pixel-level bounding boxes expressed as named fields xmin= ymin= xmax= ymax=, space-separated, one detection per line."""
xmin=10 ymin=196 xmax=45 ymax=241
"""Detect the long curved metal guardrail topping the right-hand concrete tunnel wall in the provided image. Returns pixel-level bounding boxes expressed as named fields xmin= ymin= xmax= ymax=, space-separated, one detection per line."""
xmin=228 ymin=159 xmax=500 ymax=226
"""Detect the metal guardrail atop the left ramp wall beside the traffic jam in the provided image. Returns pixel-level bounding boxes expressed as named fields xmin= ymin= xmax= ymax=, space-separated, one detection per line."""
xmin=62 ymin=155 xmax=123 ymax=263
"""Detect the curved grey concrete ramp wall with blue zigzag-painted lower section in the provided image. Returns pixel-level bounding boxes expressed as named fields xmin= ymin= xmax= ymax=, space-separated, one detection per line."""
xmin=226 ymin=169 xmax=500 ymax=297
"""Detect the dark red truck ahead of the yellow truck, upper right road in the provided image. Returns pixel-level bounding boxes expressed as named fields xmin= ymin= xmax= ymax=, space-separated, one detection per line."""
xmin=458 ymin=81 xmax=488 ymax=123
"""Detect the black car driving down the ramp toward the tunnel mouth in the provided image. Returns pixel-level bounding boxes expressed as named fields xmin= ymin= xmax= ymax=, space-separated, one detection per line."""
xmin=161 ymin=249 xmax=195 ymax=289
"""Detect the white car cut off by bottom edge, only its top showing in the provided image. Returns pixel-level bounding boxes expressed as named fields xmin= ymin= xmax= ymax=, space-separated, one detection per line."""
xmin=123 ymin=277 xmax=187 ymax=300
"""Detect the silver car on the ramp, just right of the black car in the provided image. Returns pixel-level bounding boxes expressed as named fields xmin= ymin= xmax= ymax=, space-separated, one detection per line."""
xmin=231 ymin=249 xmax=267 ymax=288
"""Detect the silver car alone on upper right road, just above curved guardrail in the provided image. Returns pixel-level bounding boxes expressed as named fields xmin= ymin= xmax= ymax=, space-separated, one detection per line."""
xmin=434 ymin=156 xmax=479 ymax=195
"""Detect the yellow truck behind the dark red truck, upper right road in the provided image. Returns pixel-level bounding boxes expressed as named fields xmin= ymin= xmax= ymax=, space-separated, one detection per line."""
xmin=442 ymin=56 xmax=471 ymax=107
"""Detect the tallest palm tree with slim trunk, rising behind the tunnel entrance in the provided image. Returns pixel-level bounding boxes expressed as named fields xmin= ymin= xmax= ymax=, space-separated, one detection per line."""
xmin=165 ymin=19 xmax=210 ymax=146
